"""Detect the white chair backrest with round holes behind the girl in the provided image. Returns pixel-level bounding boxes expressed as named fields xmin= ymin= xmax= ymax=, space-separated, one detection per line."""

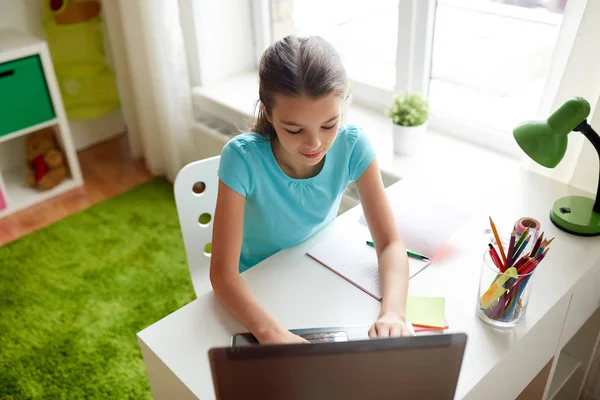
xmin=174 ymin=156 xmax=220 ymax=296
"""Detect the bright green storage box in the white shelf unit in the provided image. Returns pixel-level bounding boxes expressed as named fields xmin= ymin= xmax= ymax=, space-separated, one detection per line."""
xmin=0 ymin=56 xmax=55 ymax=136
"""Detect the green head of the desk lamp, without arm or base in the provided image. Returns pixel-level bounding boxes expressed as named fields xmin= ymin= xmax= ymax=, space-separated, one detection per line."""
xmin=513 ymin=97 xmax=590 ymax=168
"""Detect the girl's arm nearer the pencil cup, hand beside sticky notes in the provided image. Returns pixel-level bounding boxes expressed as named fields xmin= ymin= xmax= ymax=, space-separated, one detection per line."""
xmin=356 ymin=159 xmax=414 ymax=337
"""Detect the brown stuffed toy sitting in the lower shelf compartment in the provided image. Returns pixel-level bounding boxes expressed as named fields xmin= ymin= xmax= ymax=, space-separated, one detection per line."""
xmin=25 ymin=128 xmax=67 ymax=190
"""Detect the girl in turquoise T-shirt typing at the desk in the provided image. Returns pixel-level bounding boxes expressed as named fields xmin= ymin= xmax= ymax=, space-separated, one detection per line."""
xmin=210 ymin=36 xmax=414 ymax=343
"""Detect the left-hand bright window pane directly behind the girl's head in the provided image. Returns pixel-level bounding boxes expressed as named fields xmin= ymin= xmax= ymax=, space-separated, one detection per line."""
xmin=271 ymin=0 xmax=398 ymax=91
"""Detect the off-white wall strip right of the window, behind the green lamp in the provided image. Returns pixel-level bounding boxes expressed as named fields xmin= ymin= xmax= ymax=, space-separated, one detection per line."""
xmin=530 ymin=0 xmax=600 ymax=194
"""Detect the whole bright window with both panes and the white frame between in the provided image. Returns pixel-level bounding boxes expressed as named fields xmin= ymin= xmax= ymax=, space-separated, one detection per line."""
xmin=262 ymin=0 xmax=566 ymax=155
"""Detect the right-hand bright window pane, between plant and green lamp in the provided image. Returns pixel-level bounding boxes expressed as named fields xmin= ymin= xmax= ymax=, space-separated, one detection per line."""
xmin=429 ymin=0 xmax=565 ymax=133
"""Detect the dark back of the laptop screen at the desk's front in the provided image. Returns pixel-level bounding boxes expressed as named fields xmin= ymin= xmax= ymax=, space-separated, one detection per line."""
xmin=208 ymin=333 xmax=467 ymax=400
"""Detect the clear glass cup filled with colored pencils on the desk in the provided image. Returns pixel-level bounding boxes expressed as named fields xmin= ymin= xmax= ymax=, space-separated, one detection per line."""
xmin=477 ymin=218 xmax=554 ymax=328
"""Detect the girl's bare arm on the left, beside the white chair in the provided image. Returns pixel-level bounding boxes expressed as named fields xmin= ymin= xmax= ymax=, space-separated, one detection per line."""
xmin=210 ymin=181 xmax=305 ymax=343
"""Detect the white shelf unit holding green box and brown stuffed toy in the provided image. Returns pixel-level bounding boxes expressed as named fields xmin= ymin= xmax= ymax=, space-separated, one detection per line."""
xmin=0 ymin=30 xmax=83 ymax=218
